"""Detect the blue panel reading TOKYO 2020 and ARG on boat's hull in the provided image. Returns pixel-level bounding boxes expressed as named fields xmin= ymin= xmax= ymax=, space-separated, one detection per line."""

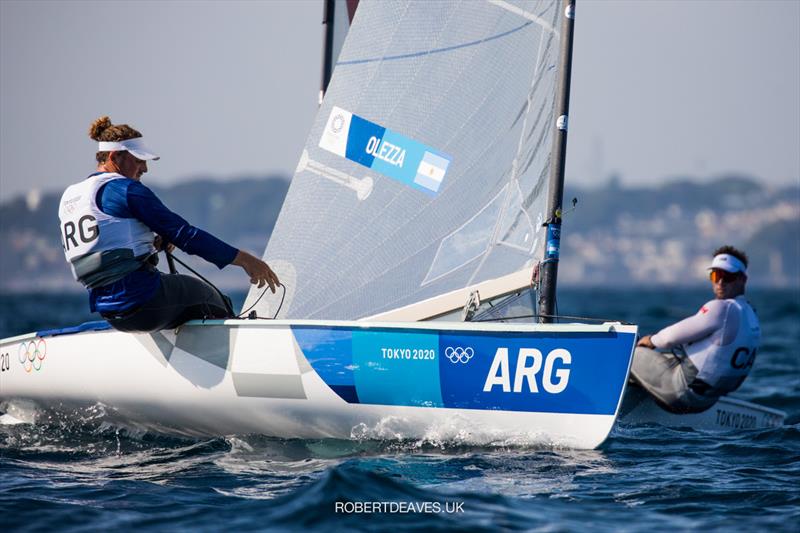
xmin=292 ymin=326 xmax=635 ymax=415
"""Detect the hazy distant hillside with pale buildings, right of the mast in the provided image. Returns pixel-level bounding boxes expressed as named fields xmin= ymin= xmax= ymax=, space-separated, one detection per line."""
xmin=559 ymin=176 xmax=800 ymax=287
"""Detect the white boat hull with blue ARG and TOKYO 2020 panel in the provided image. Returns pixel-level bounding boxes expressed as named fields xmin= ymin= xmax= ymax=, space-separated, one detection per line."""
xmin=0 ymin=320 xmax=636 ymax=448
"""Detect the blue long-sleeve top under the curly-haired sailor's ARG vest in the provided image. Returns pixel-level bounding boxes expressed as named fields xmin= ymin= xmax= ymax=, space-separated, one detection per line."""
xmin=89 ymin=179 xmax=238 ymax=313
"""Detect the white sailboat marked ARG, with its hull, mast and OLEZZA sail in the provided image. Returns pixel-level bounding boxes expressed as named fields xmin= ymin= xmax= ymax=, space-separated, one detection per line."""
xmin=0 ymin=0 xmax=782 ymax=448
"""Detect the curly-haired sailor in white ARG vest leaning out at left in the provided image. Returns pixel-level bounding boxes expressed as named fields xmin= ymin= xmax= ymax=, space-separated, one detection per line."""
xmin=58 ymin=117 xmax=279 ymax=331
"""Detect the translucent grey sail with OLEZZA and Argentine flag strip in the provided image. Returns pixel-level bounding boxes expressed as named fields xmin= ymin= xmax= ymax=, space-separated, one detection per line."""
xmin=245 ymin=0 xmax=564 ymax=319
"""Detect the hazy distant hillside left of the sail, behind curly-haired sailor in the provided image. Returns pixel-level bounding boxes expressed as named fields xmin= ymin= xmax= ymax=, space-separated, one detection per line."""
xmin=0 ymin=176 xmax=289 ymax=290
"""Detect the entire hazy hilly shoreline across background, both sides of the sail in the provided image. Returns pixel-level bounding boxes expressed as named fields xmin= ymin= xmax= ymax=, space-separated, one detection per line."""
xmin=0 ymin=176 xmax=800 ymax=291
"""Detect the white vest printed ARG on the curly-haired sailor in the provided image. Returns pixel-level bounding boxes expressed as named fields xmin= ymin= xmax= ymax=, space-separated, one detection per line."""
xmin=58 ymin=172 xmax=156 ymax=287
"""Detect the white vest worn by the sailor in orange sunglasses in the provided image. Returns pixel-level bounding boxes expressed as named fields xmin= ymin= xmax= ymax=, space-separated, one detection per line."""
xmin=684 ymin=295 xmax=761 ymax=392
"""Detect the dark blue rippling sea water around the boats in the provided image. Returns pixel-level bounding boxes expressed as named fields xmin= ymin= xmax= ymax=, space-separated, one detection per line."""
xmin=0 ymin=287 xmax=800 ymax=532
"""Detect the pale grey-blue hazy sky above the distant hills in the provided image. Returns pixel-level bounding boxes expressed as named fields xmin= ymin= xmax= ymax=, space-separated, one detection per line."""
xmin=0 ymin=0 xmax=800 ymax=201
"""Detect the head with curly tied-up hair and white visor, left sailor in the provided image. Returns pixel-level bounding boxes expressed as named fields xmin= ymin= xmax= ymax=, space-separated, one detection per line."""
xmin=89 ymin=116 xmax=158 ymax=181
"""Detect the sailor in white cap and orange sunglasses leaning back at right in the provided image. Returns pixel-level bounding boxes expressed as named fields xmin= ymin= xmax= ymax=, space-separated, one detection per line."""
xmin=631 ymin=246 xmax=761 ymax=413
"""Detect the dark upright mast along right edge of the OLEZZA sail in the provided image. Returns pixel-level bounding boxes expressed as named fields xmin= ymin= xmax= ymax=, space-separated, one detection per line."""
xmin=539 ymin=0 xmax=575 ymax=323
